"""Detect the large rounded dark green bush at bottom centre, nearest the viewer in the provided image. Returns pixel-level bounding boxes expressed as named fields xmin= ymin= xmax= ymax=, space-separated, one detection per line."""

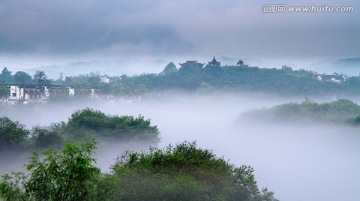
xmin=101 ymin=142 xmax=276 ymax=201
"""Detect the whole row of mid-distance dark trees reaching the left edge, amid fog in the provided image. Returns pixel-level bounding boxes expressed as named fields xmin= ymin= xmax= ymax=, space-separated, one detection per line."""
xmin=0 ymin=108 xmax=159 ymax=155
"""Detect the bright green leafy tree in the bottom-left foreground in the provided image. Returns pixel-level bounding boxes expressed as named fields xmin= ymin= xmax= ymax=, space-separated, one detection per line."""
xmin=26 ymin=141 xmax=100 ymax=201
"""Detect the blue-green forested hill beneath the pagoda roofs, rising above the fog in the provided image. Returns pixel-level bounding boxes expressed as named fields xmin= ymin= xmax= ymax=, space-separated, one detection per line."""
xmin=104 ymin=63 xmax=360 ymax=96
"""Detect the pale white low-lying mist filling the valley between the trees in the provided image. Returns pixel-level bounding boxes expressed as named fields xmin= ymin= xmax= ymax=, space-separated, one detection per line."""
xmin=0 ymin=94 xmax=360 ymax=201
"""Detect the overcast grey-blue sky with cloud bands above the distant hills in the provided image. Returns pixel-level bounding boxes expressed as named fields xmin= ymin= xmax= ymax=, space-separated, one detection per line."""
xmin=0 ymin=0 xmax=360 ymax=75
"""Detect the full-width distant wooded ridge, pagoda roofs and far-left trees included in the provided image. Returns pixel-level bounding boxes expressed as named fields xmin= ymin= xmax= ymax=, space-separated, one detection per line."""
xmin=0 ymin=61 xmax=360 ymax=96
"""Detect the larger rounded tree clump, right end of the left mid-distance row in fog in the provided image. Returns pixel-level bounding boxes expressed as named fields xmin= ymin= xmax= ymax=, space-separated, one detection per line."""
xmin=53 ymin=108 xmax=159 ymax=142
